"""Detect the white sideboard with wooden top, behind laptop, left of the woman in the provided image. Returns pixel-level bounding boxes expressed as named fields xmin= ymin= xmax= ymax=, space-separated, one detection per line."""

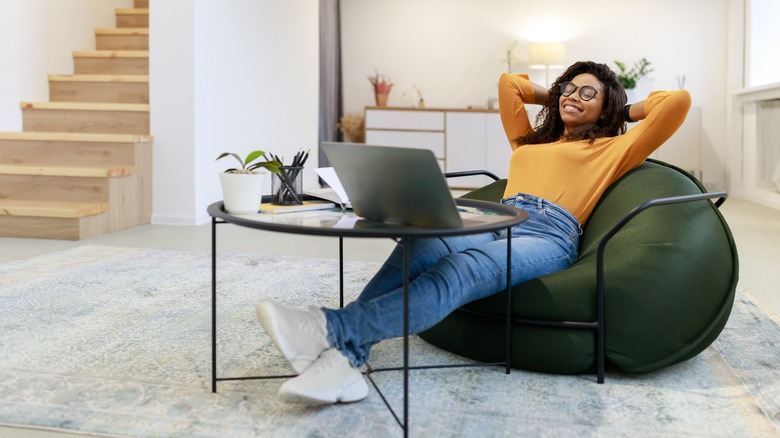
xmin=365 ymin=107 xmax=511 ymax=189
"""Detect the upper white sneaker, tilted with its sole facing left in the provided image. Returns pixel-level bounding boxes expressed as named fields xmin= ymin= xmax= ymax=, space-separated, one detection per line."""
xmin=256 ymin=301 xmax=330 ymax=374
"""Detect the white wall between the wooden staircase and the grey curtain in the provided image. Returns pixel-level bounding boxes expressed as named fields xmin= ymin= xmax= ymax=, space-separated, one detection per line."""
xmin=150 ymin=0 xmax=319 ymax=224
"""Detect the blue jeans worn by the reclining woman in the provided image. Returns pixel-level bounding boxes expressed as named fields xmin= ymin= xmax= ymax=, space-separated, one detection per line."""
xmin=323 ymin=194 xmax=581 ymax=367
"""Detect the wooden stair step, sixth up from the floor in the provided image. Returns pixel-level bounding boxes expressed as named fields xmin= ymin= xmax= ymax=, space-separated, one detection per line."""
xmin=73 ymin=50 xmax=149 ymax=75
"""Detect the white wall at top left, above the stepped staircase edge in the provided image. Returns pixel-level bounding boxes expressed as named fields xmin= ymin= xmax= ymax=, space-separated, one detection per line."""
xmin=0 ymin=0 xmax=132 ymax=131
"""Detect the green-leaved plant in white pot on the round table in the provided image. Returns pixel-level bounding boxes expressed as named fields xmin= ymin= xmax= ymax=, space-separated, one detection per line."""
xmin=217 ymin=150 xmax=282 ymax=214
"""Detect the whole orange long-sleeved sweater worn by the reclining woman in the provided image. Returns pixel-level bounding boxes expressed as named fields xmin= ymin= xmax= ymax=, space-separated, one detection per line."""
xmin=498 ymin=74 xmax=691 ymax=224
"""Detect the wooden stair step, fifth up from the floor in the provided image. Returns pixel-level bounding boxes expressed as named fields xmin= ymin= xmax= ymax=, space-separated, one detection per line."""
xmin=49 ymin=75 xmax=149 ymax=103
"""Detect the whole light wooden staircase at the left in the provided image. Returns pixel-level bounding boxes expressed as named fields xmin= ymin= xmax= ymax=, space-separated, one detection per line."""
xmin=0 ymin=0 xmax=152 ymax=240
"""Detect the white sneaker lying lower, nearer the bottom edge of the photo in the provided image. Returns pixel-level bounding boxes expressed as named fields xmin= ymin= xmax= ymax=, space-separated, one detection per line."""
xmin=279 ymin=348 xmax=368 ymax=404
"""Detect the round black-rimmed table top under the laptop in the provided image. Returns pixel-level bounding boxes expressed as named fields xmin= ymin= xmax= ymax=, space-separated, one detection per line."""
xmin=208 ymin=199 xmax=528 ymax=237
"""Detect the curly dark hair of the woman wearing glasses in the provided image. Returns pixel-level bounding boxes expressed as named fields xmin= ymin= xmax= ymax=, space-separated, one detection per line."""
xmin=515 ymin=61 xmax=627 ymax=145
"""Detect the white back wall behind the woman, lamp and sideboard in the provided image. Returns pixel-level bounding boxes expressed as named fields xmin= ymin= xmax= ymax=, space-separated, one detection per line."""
xmin=341 ymin=0 xmax=728 ymax=191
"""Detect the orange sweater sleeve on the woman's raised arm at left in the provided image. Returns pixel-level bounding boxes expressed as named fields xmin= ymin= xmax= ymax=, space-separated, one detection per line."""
xmin=498 ymin=73 xmax=536 ymax=149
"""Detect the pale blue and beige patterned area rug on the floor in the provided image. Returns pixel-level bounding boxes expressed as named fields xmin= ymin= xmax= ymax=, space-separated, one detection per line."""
xmin=0 ymin=245 xmax=780 ymax=437
